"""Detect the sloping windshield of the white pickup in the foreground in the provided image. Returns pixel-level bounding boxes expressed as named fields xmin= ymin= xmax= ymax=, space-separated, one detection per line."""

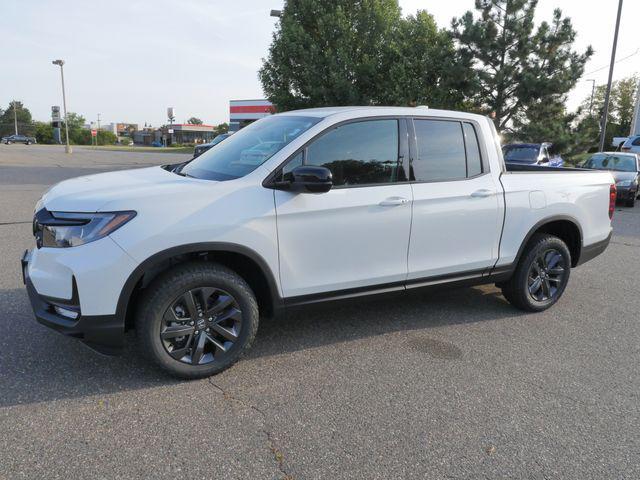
xmin=179 ymin=115 xmax=322 ymax=180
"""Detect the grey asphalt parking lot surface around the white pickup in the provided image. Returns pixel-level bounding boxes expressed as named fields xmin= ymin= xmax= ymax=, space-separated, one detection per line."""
xmin=0 ymin=145 xmax=640 ymax=480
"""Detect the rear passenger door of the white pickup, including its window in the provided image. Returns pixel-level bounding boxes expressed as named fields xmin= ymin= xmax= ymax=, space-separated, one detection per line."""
xmin=408 ymin=118 xmax=502 ymax=284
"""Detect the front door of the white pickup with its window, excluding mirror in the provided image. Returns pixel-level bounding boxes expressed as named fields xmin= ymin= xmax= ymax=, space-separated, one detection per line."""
xmin=275 ymin=118 xmax=411 ymax=297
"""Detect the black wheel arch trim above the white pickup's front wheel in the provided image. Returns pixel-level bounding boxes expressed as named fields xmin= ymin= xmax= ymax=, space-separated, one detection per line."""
xmin=116 ymin=242 xmax=282 ymax=330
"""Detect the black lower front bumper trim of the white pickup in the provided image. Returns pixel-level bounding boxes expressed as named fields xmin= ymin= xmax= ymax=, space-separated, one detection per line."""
xmin=21 ymin=250 xmax=124 ymax=355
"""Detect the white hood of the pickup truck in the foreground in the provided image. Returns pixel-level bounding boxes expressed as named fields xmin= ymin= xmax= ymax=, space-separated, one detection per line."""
xmin=42 ymin=167 xmax=215 ymax=212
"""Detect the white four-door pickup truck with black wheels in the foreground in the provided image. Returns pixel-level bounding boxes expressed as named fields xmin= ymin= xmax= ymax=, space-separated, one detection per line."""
xmin=22 ymin=107 xmax=616 ymax=378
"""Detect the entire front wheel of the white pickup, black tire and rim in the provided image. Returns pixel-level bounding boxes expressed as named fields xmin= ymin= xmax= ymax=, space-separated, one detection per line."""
xmin=136 ymin=262 xmax=259 ymax=379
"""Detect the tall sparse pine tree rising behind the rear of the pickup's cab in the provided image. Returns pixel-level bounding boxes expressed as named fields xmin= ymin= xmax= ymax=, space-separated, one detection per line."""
xmin=452 ymin=0 xmax=593 ymax=132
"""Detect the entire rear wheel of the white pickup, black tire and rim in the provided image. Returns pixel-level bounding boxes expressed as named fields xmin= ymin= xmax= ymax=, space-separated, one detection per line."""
xmin=501 ymin=233 xmax=571 ymax=312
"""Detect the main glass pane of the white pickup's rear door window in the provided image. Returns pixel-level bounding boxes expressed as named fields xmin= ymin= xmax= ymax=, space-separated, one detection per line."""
xmin=410 ymin=119 xmax=467 ymax=182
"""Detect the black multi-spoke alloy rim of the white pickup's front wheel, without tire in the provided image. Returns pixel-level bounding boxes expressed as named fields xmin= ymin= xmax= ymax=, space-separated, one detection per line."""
xmin=159 ymin=287 xmax=242 ymax=365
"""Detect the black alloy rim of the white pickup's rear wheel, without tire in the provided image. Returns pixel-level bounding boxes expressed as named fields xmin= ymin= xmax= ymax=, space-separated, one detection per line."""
xmin=527 ymin=248 xmax=566 ymax=302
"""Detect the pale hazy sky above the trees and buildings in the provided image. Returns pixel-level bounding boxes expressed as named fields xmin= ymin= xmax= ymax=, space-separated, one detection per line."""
xmin=0 ymin=0 xmax=640 ymax=126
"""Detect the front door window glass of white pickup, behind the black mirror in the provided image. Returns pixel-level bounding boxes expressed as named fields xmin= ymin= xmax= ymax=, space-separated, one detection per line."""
xmin=304 ymin=120 xmax=399 ymax=186
